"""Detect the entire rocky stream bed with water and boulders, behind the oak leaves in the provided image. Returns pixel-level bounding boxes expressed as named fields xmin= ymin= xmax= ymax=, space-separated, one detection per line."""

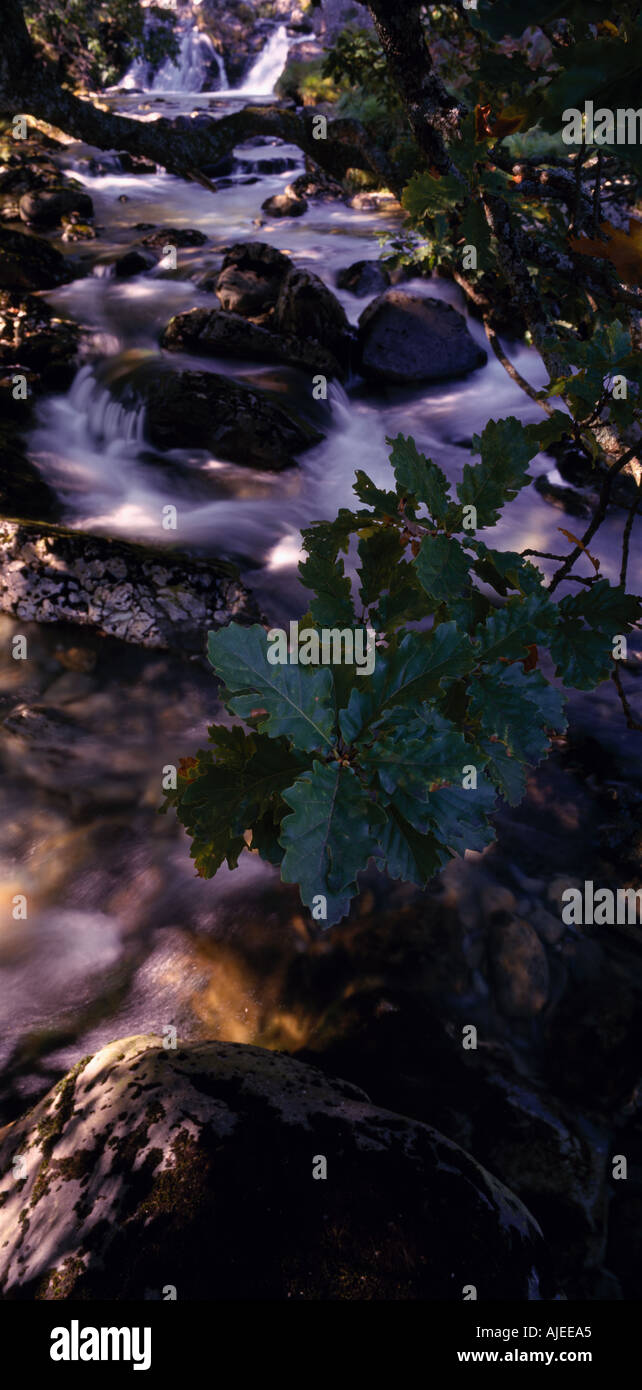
xmin=0 ymin=6 xmax=642 ymax=1300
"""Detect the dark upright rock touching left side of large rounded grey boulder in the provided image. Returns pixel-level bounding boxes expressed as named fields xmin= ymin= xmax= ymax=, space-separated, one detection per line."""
xmin=274 ymin=265 xmax=353 ymax=363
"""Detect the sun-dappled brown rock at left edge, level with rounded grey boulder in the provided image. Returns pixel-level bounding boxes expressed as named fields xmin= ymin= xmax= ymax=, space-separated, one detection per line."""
xmin=0 ymin=289 xmax=79 ymax=389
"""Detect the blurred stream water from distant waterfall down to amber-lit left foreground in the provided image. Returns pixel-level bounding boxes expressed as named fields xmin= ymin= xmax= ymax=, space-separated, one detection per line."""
xmin=0 ymin=29 xmax=642 ymax=1119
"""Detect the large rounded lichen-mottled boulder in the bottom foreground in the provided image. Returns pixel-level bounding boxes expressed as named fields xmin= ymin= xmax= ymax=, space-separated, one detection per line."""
xmin=0 ymin=1036 xmax=550 ymax=1301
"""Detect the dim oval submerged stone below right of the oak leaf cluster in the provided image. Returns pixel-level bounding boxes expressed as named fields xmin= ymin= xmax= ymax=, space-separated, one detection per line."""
xmin=491 ymin=917 xmax=549 ymax=1019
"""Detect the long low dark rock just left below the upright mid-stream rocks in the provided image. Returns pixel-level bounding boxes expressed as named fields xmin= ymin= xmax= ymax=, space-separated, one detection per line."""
xmin=161 ymin=309 xmax=342 ymax=377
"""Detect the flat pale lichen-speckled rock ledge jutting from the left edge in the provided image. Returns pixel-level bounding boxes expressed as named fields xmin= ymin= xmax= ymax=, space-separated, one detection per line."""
xmin=0 ymin=521 xmax=258 ymax=653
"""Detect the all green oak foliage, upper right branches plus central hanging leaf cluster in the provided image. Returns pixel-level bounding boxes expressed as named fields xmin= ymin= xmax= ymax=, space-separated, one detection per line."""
xmin=167 ymin=0 xmax=642 ymax=923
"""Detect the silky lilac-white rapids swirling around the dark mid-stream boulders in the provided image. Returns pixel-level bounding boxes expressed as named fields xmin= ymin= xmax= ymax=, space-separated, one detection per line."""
xmin=31 ymin=138 xmax=635 ymax=603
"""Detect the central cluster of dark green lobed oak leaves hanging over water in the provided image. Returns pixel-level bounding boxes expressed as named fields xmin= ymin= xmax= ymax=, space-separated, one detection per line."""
xmin=167 ymin=422 xmax=642 ymax=924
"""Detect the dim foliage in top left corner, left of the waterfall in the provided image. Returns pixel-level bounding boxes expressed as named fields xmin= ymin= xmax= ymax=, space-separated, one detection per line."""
xmin=24 ymin=0 xmax=178 ymax=89
